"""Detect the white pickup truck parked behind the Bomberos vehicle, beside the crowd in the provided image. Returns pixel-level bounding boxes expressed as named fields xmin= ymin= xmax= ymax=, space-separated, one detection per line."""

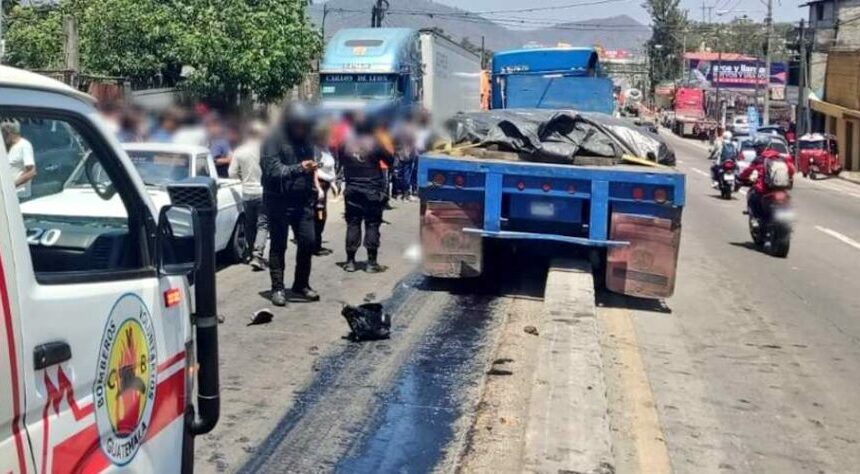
xmin=21 ymin=143 xmax=247 ymax=262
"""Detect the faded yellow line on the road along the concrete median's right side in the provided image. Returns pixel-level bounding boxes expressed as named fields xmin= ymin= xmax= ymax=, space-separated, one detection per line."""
xmin=597 ymin=308 xmax=672 ymax=474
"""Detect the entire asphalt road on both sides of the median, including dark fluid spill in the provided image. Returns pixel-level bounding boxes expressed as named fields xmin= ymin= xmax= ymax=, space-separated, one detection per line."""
xmin=196 ymin=136 xmax=860 ymax=474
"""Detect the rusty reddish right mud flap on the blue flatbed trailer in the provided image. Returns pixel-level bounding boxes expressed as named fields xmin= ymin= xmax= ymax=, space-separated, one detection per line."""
xmin=606 ymin=213 xmax=681 ymax=298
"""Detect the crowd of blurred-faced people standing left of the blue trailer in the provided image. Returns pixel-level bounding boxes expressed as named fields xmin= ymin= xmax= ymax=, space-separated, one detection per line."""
xmin=84 ymin=99 xmax=431 ymax=306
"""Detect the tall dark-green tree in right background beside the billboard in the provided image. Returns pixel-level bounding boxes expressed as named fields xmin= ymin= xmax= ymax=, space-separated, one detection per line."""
xmin=642 ymin=0 xmax=687 ymax=84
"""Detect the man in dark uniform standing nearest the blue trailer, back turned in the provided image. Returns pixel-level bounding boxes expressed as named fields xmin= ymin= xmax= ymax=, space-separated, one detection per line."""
xmin=341 ymin=115 xmax=394 ymax=273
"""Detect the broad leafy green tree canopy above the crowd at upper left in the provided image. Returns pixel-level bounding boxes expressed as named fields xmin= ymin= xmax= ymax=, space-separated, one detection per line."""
xmin=7 ymin=0 xmax=321 ymax=105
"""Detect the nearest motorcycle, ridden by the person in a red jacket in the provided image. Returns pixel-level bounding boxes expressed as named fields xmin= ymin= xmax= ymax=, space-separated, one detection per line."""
xmin=745 ymin=190 xmax=795 ymax=258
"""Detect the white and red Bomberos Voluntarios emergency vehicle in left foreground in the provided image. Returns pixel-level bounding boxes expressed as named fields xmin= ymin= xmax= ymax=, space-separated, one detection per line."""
xmin=0 ymin=66 xmax=219 ymax=474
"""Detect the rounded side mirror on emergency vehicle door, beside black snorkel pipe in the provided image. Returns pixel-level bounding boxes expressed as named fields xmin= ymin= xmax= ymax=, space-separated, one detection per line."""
xmin=156 ymin=205 xmax=203 ymax=275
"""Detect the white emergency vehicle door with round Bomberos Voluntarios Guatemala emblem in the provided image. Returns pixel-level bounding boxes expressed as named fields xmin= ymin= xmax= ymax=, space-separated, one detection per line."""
xmin=0 ymin=109 xmax=188 ymax=473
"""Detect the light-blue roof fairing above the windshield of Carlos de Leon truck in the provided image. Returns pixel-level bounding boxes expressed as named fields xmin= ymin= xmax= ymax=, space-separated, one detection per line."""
xmin=320 ymin=28 xmax=418 ymax=74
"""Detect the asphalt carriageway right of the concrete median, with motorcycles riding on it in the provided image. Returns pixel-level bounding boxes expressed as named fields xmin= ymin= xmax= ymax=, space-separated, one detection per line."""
xmin=600 ymin=134 xmax=860 ymax=473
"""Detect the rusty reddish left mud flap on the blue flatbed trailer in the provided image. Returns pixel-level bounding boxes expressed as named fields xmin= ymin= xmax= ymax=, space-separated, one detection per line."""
xmin=421 ymin=201 xmax=483 ymax=278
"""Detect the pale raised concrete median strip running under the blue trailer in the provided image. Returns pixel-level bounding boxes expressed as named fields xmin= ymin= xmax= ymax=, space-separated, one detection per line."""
xmin=523 ymin=259 xmax=614 ymax=473
